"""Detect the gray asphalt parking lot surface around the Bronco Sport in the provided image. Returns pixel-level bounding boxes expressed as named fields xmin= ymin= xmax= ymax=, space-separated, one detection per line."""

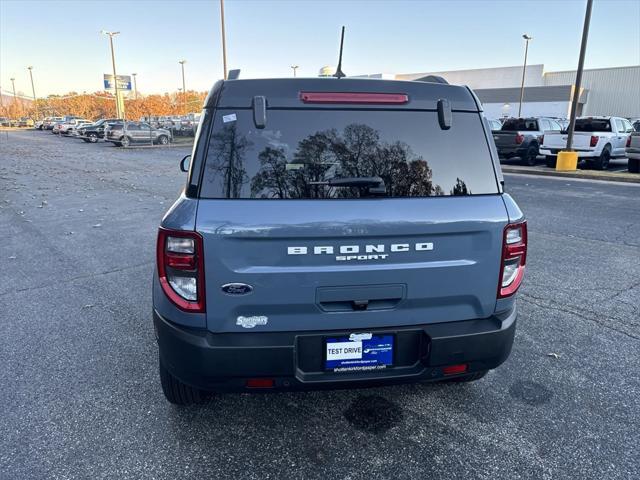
xmin=0 ymin=131 xmax=640 ymax=479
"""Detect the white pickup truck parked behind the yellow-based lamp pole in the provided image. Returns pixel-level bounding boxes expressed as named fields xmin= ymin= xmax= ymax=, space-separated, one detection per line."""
xmin=540 ymin=117 xmax=633 ymax=170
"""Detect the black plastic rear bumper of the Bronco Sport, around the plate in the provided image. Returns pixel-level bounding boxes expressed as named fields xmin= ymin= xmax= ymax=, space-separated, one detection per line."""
xmin=153 ymin=307 xmax=516 ymax=391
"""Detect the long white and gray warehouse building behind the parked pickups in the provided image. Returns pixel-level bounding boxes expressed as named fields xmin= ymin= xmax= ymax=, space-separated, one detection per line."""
xmin=367 ymin=64 xmax=640 ymax=118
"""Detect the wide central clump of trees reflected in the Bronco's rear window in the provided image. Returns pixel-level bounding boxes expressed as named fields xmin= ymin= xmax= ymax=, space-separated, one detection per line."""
xmin=248 ymin=123 xmax=448 ymax=198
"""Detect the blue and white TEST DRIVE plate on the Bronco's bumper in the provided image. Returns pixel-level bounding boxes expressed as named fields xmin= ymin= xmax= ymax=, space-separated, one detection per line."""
xmin=325 ymin=333 xmax=393 ymax=372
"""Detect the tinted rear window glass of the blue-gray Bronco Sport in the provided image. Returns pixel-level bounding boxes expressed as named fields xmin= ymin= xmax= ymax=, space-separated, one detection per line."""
xmin=200 ymin=109 xmax=498 ymax=199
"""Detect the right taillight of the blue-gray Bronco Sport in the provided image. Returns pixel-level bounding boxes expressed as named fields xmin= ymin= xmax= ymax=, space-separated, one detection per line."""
xmin=498 ymin=221 xmax=527 ymax=298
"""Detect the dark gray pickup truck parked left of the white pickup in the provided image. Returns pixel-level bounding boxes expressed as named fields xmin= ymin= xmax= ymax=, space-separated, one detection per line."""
xmin=493 ymin=117 xmax=562 ymax=166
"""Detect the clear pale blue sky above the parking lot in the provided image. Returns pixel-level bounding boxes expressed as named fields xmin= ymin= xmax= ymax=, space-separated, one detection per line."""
xmin=0 ymin=0 xmax=640 ymax=97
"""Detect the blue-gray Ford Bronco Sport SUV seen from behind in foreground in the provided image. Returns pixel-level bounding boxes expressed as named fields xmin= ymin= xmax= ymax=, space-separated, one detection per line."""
xmin=153 ymin=78 xmax=527 ymax=405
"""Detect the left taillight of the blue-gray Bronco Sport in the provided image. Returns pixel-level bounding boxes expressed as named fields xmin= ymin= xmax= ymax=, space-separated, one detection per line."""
xmin=156 ymin=228 xmax=205 ymax=313
